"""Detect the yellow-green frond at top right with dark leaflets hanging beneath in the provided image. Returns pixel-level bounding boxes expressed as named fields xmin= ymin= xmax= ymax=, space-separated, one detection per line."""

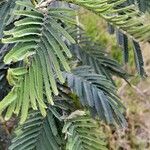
xmin=60 ymin=0 xmax=149 ymax=77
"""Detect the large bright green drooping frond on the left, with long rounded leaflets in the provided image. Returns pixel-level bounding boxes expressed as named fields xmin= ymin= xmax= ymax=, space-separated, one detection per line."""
xmin=0 ymin=2 xmax=74 ymax=122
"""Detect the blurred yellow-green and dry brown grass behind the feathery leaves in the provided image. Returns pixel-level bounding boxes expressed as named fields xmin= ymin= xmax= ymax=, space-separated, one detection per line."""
xmin=79 ymin=9 xmax=150 ymax=150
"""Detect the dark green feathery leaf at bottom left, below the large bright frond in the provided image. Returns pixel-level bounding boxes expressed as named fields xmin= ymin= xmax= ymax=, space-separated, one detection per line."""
xmin=8 ymin=96 xmax=75 ymax=150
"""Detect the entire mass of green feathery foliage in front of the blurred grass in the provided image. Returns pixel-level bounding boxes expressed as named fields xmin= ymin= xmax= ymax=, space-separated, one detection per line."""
xmin=0 ymin=0 xmax=150 ymax=150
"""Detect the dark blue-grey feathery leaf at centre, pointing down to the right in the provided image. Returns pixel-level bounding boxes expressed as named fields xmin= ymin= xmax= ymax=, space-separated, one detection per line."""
xmin=64 ymin=66 xmax=126 ymax=126
